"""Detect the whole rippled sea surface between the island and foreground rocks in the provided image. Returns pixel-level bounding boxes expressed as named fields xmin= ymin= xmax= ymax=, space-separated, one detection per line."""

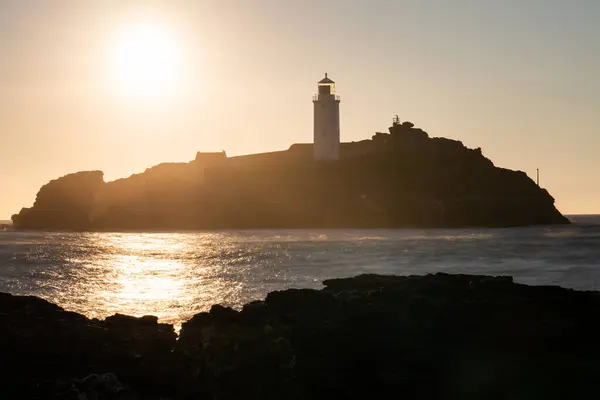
xmin=0 ymin=215 xmax=600 ymax=325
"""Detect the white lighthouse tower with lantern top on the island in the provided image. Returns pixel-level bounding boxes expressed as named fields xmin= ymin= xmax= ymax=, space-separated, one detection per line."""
xmin=313 ymin=73 xmax=340 ymax=161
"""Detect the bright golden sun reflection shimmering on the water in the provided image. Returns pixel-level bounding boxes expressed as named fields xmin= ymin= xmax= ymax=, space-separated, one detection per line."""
xmin=81 ymin=233 xmax=240 ymax=323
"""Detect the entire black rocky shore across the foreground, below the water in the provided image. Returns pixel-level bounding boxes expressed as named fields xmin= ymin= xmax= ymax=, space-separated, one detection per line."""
xmin=0 ymin=274 xmax=600 ymax=400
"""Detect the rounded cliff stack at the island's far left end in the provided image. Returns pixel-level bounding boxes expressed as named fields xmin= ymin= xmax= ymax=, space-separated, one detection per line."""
xmin=12 ymin=171 xmax=104 ymax=230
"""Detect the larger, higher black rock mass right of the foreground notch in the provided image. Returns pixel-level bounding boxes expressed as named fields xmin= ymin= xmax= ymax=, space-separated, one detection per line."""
xmin=178 ymin=274 xmax=600 ymax=399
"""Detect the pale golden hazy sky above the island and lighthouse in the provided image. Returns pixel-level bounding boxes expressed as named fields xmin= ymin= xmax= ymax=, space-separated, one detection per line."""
xmin=0 ymin=0 xmax=600 ymax=219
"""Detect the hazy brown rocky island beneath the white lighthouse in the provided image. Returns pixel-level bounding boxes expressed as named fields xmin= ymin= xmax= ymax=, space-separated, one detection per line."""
xmin=12 ymin=121 xmax=569 ymax=230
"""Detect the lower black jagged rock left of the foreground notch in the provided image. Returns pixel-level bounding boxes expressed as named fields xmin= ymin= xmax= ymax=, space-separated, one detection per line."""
xmin=0 ymin=293 xmax=177 ymax=399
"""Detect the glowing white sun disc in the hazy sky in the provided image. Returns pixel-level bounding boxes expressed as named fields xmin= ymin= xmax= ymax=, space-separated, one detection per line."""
xmin=111 ymin=25 xmax=181 ymax=98
